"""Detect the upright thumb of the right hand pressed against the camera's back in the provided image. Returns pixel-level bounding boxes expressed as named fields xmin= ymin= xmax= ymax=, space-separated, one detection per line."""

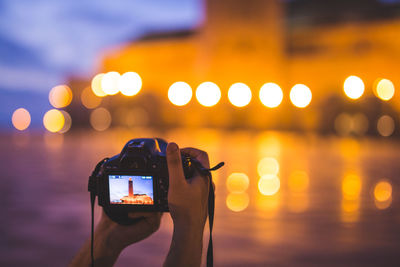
xmin=167 ymin=143 xmax=186 ymax=188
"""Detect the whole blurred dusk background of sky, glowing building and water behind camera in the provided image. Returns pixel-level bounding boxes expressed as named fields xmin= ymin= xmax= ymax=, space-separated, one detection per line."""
xmin=0 ymin=0 xmax=400 ymax=266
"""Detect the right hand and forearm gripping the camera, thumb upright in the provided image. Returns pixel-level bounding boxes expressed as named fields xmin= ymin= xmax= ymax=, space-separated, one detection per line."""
xmin=164 ymin=143 xmax=210 ymax=267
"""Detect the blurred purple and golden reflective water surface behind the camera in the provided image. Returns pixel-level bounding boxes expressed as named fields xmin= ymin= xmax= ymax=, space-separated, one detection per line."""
xmin=0 ymin=128 xmax=400 ymax=266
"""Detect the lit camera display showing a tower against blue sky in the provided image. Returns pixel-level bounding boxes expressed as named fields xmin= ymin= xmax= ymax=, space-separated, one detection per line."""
xmin=108 ymin=175 xmax=154 ymax=205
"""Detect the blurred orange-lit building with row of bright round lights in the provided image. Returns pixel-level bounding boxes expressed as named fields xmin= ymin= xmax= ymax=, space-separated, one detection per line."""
xmin=68 ymin=0 xmax=400 ymax=135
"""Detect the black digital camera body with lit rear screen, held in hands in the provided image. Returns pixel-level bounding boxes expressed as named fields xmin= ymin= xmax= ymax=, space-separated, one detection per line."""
xmin=89 ymin=138 xmax=195 ymax=225
